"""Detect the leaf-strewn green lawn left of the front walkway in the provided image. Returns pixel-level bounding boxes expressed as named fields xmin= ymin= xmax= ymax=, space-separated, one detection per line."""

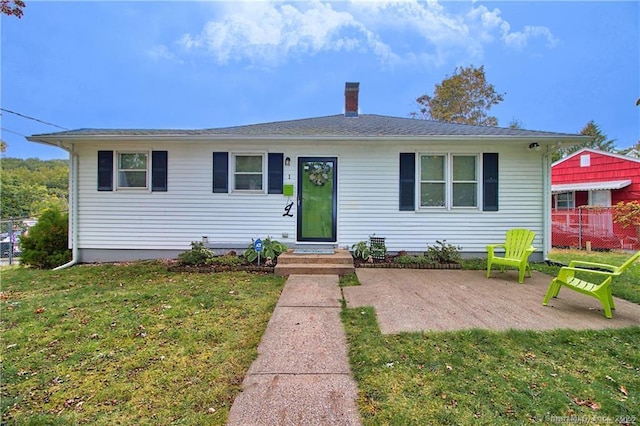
xmin=0 ymin=263 xmax=284 ymax=425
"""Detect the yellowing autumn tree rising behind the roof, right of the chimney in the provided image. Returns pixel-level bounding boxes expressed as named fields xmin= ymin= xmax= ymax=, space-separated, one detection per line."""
xmin=411 ymin=65 xmax=504 ymax=126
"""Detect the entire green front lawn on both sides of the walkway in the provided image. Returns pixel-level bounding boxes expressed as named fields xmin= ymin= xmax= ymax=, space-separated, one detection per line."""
xmin=0 ymin=252 xmax=640 ymax=425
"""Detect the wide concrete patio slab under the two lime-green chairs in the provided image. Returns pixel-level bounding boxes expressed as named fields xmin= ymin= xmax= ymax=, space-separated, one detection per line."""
xmin=343 ymin=268 xmax=640 ymax=334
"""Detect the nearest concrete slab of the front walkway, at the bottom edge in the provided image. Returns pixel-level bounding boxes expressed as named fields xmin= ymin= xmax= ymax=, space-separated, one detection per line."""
xmin=227 ymin=374 xmax=361 ymax=426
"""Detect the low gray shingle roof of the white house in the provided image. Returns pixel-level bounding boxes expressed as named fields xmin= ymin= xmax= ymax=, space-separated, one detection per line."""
xmin=31 ymin=114 xmax=577 ymax=138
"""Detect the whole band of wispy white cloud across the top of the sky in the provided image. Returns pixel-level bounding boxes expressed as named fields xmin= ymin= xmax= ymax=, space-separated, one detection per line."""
xmin=169 ymin=0 xmax=557 ymax=66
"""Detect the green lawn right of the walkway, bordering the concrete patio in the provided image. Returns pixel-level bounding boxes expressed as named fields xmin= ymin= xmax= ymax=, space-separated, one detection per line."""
xmin=342 ymin=252 xmax=640 ymax=425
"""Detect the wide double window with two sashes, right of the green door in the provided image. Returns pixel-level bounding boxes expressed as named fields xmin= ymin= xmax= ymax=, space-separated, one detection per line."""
xmin=419 ymin=154 xmax=479 ymax=208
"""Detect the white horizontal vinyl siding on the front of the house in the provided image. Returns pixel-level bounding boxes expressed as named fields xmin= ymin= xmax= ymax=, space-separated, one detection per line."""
xmin=76 ymin=140 xmax=544 ymax=260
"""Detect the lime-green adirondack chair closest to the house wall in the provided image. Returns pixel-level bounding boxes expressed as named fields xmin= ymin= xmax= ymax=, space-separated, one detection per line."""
xmin=487 ymin=228 xmax=536 ymax=284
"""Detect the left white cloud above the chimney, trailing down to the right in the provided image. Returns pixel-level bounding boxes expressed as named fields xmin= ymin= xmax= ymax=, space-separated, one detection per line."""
xmin=178 ymin=1 xmax=391 ymax=64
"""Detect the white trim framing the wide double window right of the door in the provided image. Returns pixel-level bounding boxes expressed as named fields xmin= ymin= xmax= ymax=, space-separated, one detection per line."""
xmin=416 ymin=152 xmax=482 ymax=211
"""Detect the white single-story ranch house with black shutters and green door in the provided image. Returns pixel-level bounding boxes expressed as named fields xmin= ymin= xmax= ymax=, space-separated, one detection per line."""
xmin=28 ymin=83 xmax=585 ymax=262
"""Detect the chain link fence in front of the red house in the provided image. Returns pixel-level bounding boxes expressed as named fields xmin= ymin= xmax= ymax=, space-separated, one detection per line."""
xmin=551 ymin=207 xmax=640 ymax=250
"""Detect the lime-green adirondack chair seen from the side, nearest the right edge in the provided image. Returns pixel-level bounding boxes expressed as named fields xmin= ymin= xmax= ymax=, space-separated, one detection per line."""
xmin=542 ymin=251 xmax=640 ymax=318
